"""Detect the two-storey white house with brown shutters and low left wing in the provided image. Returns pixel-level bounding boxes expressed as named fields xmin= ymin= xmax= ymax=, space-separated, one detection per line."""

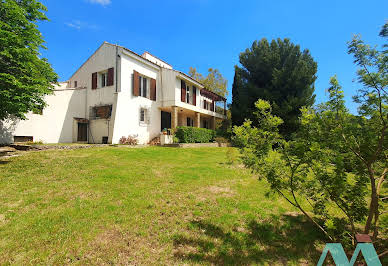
xmin=0 ymin=42 xmax=226 ymax=143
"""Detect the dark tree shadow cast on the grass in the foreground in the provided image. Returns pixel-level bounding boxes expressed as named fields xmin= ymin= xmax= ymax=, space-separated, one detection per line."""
xmin=174 ymin=215 xmax=325 ymax=265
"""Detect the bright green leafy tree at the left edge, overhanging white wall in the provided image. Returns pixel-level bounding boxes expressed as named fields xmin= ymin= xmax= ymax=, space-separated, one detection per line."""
xmin=0 ymin=0 xmax=57 ymax=120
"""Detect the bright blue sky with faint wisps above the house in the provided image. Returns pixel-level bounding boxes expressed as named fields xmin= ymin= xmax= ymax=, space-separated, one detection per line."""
xmin=39 ymin=0 xmax=388 ymax=112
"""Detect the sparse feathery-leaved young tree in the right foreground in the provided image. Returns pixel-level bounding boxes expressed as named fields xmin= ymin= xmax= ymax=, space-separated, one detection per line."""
xmin=234 ymin=23 xmax=388 ymax=244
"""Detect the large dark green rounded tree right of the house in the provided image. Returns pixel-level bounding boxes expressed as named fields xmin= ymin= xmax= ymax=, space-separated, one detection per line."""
xmin=231 ymin=38 xmax=317 ymax=138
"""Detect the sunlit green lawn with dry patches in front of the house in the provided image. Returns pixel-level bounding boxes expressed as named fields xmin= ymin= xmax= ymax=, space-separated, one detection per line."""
xmin=0 ymin=147 xmax=324 ymax=265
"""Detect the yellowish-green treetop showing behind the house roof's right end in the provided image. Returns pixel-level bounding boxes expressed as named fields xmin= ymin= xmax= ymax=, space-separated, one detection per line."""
xmin=189 ymin=67 xmax=228 ymax=97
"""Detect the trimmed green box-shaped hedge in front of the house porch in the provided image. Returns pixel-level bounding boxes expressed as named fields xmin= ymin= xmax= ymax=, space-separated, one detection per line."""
xmin=175 ymin=127 xmax=216 ymax=143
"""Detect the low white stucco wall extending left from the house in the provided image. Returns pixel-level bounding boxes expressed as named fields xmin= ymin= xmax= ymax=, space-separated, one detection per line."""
xmin=0 ymin=84 xmax=85 ymax=143
